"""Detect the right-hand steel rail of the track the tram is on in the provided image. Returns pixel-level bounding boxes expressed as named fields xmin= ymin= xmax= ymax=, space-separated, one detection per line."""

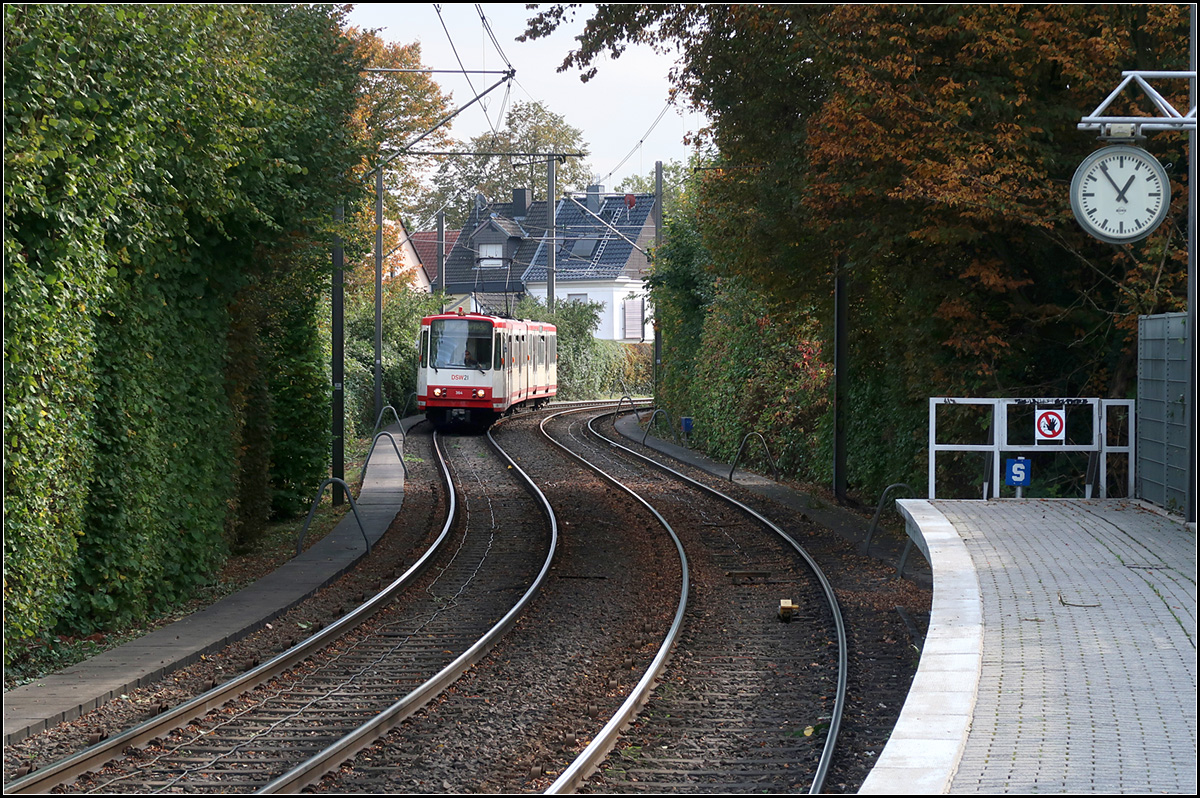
xmin=258 ymin=417 xmax=558 ymax=794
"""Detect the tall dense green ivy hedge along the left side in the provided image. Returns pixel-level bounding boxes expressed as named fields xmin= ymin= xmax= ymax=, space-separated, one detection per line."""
xmin=4 ymin=5 xmax=365 ymax=664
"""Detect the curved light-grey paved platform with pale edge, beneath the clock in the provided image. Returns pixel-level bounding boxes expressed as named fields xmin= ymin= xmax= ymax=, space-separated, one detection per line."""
xmin=862 ymin=499 xmax=1196 ymax=794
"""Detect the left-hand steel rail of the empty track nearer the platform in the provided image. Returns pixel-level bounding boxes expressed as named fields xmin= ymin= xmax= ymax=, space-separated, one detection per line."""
xmin=539 ymin=403 xmax=689 ymax=794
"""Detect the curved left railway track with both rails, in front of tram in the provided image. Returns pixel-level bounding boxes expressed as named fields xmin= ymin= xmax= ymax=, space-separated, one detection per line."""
xmin=6 ymin=429 xmax=557 ymax=793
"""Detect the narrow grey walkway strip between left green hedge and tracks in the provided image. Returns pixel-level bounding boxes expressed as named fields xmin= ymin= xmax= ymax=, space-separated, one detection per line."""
xmin=4 ymin=418 xmax=422 ymax=745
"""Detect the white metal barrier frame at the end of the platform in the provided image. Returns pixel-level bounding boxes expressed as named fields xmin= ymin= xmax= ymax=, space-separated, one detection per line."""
xmin=929 ymin=396 xmax=1138 ymax=499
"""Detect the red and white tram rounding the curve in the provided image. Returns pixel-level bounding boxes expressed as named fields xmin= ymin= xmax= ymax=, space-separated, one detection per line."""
xmin=416 ymin=310 xmax=558 ymax=427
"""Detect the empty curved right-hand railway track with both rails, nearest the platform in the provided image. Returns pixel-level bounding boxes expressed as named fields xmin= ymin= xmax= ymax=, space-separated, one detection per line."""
xmin=537 ymin=408 xmax=847 ymax=792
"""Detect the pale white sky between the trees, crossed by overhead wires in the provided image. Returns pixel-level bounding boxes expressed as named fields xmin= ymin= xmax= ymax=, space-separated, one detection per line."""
xmin=349 ymin=2 xmax=704 ymax=190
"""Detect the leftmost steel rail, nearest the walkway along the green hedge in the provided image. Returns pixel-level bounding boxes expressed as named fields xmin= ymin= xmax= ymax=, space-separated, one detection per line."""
xmin=4 ymin=433 xmax=457 ymax=794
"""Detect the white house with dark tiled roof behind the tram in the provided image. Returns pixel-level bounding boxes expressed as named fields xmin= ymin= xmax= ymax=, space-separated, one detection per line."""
xmin=434 ymin=186 xmax=654 ymax=342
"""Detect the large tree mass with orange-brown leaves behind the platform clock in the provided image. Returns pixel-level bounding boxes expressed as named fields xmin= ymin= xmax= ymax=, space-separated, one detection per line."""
xmin=527 ymin=4 xmax=1188 ymax=499
